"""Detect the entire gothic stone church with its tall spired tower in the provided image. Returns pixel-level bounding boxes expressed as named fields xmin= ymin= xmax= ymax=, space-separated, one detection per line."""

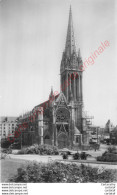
xmin=18 ymin=8 xmax=87 ymax=148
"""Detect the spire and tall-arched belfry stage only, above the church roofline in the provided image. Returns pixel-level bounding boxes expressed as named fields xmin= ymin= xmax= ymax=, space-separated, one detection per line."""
xmin=60 ymin=6 xmax=83 ymax=103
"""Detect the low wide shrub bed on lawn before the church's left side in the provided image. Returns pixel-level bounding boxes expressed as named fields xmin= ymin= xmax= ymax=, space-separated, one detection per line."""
xmin=18 ymin=144 xmax=59 ymax=155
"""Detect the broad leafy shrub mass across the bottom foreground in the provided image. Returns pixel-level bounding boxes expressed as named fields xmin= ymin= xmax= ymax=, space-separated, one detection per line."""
xmin=9 ymin=162 xmax=117 ymax=183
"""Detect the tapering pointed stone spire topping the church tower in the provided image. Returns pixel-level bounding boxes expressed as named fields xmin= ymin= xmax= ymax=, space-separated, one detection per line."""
xmin=65 ymin=6 xmax=76 ymax=57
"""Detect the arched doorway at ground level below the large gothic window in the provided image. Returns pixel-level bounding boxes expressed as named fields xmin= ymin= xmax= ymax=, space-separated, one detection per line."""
xmin=58 ymin=133 xmax=68 ymax=148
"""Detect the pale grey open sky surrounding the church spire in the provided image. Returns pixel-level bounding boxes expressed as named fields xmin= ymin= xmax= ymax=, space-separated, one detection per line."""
xmin=0 ymin=0 xmax=117 ymax=126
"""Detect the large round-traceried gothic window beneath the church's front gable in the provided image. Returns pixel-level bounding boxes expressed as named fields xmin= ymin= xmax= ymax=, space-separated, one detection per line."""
xmin=56 ymin=108 xmax=70 ymax=122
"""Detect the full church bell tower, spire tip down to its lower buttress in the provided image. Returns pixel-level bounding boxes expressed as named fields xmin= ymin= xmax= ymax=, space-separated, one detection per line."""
xmin=60 ymin=6 xmax=83 ymax=133
